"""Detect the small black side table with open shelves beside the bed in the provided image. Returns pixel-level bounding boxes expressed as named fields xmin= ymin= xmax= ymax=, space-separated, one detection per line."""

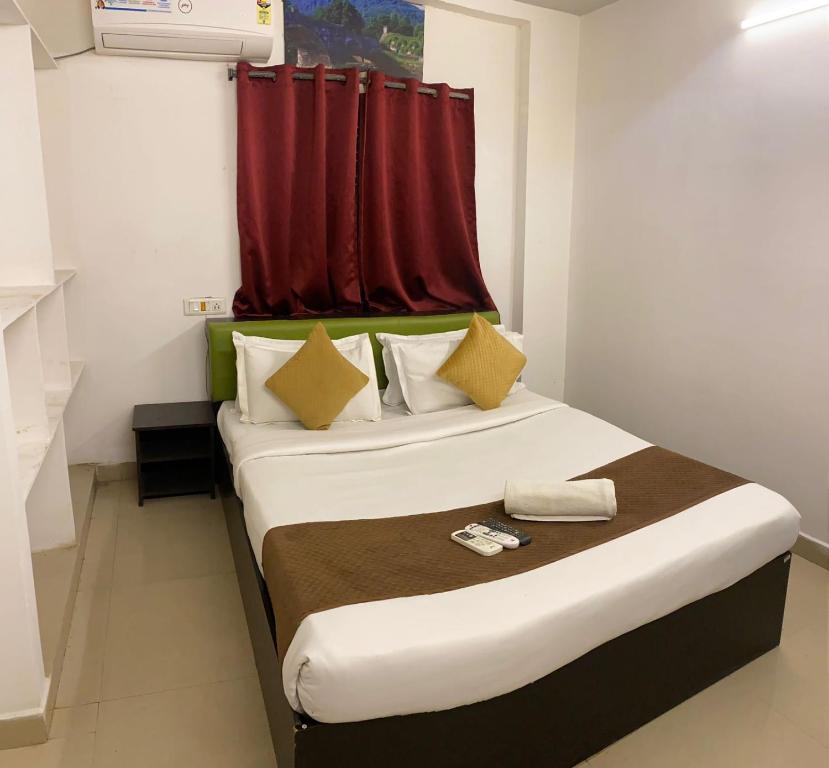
xmin=132 ymin=401 xmax=216 ymax=506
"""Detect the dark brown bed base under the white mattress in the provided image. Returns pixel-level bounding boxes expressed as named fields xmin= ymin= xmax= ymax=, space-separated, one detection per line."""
xmin=220 ymin=452 xmax=791 ymax=768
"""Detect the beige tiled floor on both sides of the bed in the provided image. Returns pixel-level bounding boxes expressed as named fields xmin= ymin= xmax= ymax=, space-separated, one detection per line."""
xmin=0 ymin=483 xmax=829 ymax=768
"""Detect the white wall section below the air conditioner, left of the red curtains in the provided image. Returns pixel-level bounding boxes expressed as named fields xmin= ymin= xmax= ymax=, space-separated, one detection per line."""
xmin=38 ymin=53 xmax=239 ymax=462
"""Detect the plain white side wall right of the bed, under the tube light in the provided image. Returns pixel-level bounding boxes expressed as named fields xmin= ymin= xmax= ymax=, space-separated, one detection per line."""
xmin=566 ymin=0 xmax=829 ymax=542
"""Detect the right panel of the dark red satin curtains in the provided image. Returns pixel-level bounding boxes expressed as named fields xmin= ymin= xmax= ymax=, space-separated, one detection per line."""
xmin=359 ymin=72 xmax=495 ymax=312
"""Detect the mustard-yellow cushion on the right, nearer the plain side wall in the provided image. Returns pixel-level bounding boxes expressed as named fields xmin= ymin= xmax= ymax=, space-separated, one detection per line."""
xmin=438 ymin=315 xmax=527 ymax=411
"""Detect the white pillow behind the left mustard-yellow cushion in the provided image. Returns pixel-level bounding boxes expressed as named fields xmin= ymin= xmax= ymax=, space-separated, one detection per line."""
xmin=233 ymin=332 xmax=381 ymax=424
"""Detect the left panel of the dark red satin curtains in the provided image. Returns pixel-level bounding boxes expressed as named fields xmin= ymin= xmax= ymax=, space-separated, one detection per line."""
xmin=233 ymin=62 xmax=362 ymax=317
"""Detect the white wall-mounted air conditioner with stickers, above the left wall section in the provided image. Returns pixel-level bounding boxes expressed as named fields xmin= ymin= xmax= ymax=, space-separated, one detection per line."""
xmin=91 ymin=0 xmax=274 ymax=61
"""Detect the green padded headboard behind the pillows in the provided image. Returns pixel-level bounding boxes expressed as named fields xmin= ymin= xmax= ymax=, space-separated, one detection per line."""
xmin=207 ymin=312 xmax=500 ymax=402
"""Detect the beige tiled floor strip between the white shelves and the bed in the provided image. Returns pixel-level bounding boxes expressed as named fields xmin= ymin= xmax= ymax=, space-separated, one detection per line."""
xmin=0 ymin=483 xmax=275 ymax=768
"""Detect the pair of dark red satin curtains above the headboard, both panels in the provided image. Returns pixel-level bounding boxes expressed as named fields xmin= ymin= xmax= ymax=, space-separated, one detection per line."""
xmin=233 ymin=62 xmax=495 ymax=318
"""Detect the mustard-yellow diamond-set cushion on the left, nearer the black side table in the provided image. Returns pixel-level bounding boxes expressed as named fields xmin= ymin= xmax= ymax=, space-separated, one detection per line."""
xmin=265 ymin=323 xmax=368 ymax=429
